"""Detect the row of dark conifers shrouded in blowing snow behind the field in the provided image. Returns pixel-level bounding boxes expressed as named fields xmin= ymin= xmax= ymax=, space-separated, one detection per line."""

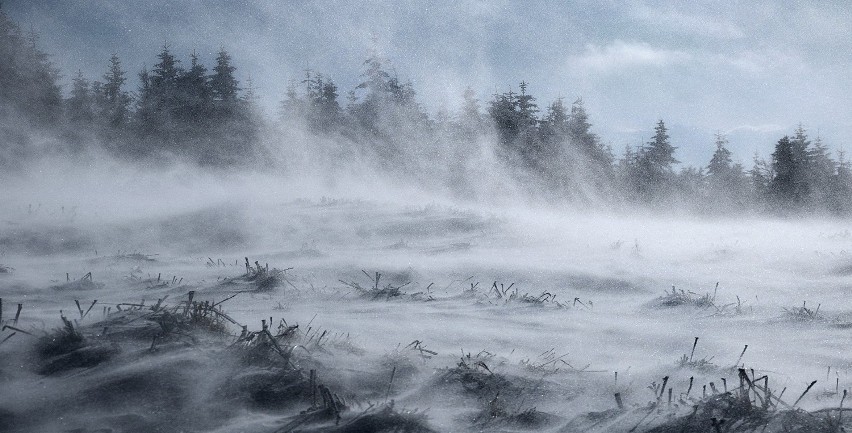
xmin=0 ymin=9 xmax=852 ymax=214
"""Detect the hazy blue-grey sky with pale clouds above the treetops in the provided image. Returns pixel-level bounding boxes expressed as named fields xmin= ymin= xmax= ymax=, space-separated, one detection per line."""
xmin=3 ymin=0 xmax=852 ymax=168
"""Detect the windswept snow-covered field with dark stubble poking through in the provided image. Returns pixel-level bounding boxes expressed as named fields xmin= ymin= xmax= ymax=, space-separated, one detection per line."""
xmin=0 ymin=167 xmax=852 ymax=432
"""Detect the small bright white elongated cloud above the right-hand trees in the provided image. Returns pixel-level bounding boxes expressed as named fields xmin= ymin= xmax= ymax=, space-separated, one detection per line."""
xmin=570 ymin=40 xmax=691 ymax=72
